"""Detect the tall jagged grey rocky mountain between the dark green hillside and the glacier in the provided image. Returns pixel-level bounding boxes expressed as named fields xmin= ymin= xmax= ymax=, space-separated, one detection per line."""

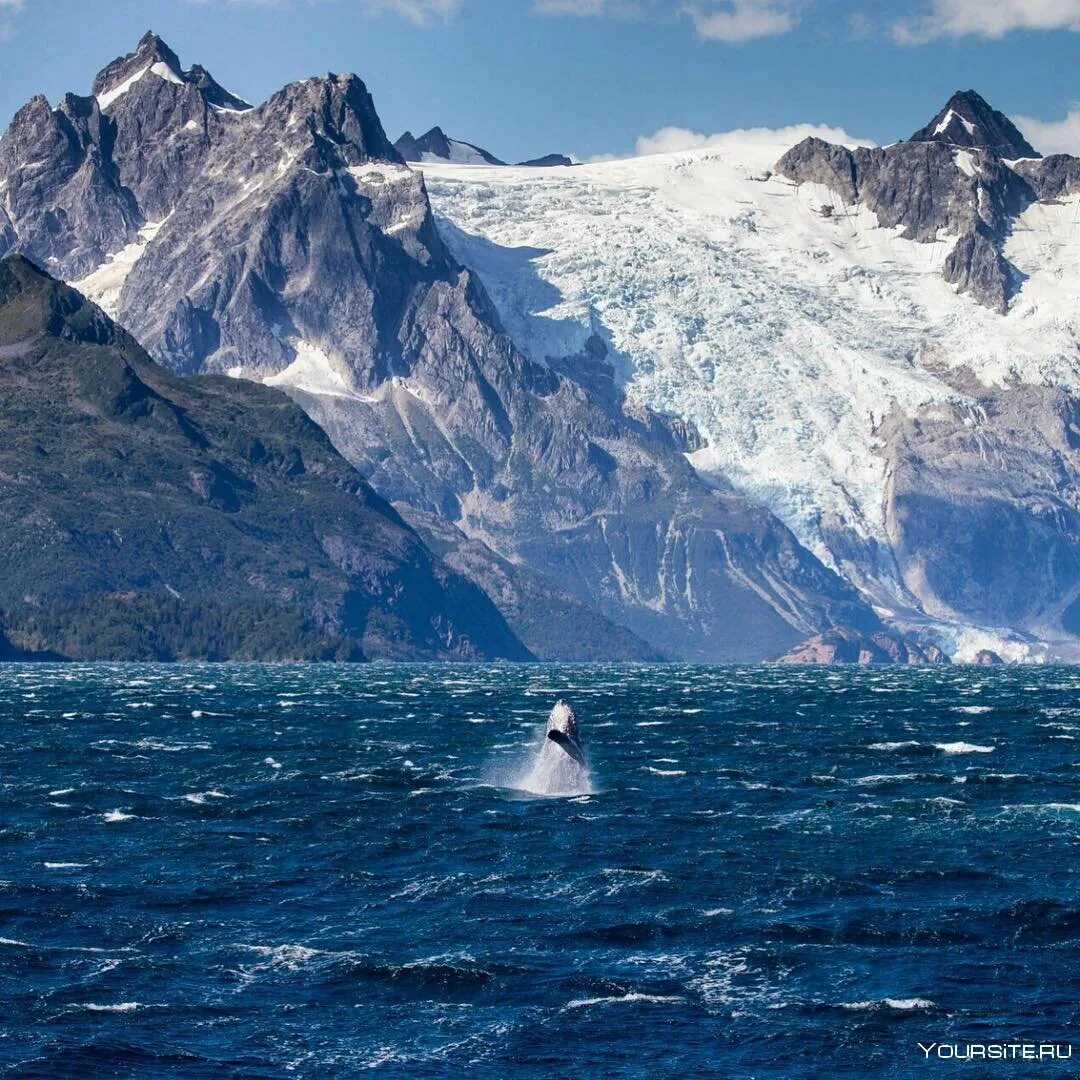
xmin=0 ymin=31 xmax=879 ymax=661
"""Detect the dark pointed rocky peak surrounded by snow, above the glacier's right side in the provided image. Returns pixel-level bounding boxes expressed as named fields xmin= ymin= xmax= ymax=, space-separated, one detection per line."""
xmin=777 ymin=91 xmax=1080 ymax=313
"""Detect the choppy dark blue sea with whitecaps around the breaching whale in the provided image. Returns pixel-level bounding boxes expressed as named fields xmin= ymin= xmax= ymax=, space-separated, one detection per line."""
xmin=0 ymin=665 xmax=1080 ymax=1078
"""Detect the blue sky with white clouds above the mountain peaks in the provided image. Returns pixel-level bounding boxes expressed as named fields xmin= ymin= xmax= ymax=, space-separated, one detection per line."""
xmin=0 ymin=0 xmax=1080 ymax=159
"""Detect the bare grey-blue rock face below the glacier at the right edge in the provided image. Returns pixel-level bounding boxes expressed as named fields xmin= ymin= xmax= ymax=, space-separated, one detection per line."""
xmin=882 ymin=387 xmax=1080 ymax=640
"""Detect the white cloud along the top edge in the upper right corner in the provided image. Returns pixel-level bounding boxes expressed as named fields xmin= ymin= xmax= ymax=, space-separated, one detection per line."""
xmin=892 ymin=0 xmax=1080 ymax=45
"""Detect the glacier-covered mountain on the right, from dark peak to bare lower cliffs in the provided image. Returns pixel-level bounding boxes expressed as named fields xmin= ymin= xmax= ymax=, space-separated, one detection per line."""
xmin=414 ymin=103 xmax=1080 ymax=656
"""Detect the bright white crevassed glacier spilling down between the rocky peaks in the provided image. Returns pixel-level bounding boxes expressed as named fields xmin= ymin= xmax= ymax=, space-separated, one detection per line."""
xmin=417 ymin=140 xmax=1080 ymax=583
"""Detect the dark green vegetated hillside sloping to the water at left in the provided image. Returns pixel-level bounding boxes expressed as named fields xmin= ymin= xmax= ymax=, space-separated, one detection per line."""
xmin=0 ymin=256 xmax=529 ymax=660
